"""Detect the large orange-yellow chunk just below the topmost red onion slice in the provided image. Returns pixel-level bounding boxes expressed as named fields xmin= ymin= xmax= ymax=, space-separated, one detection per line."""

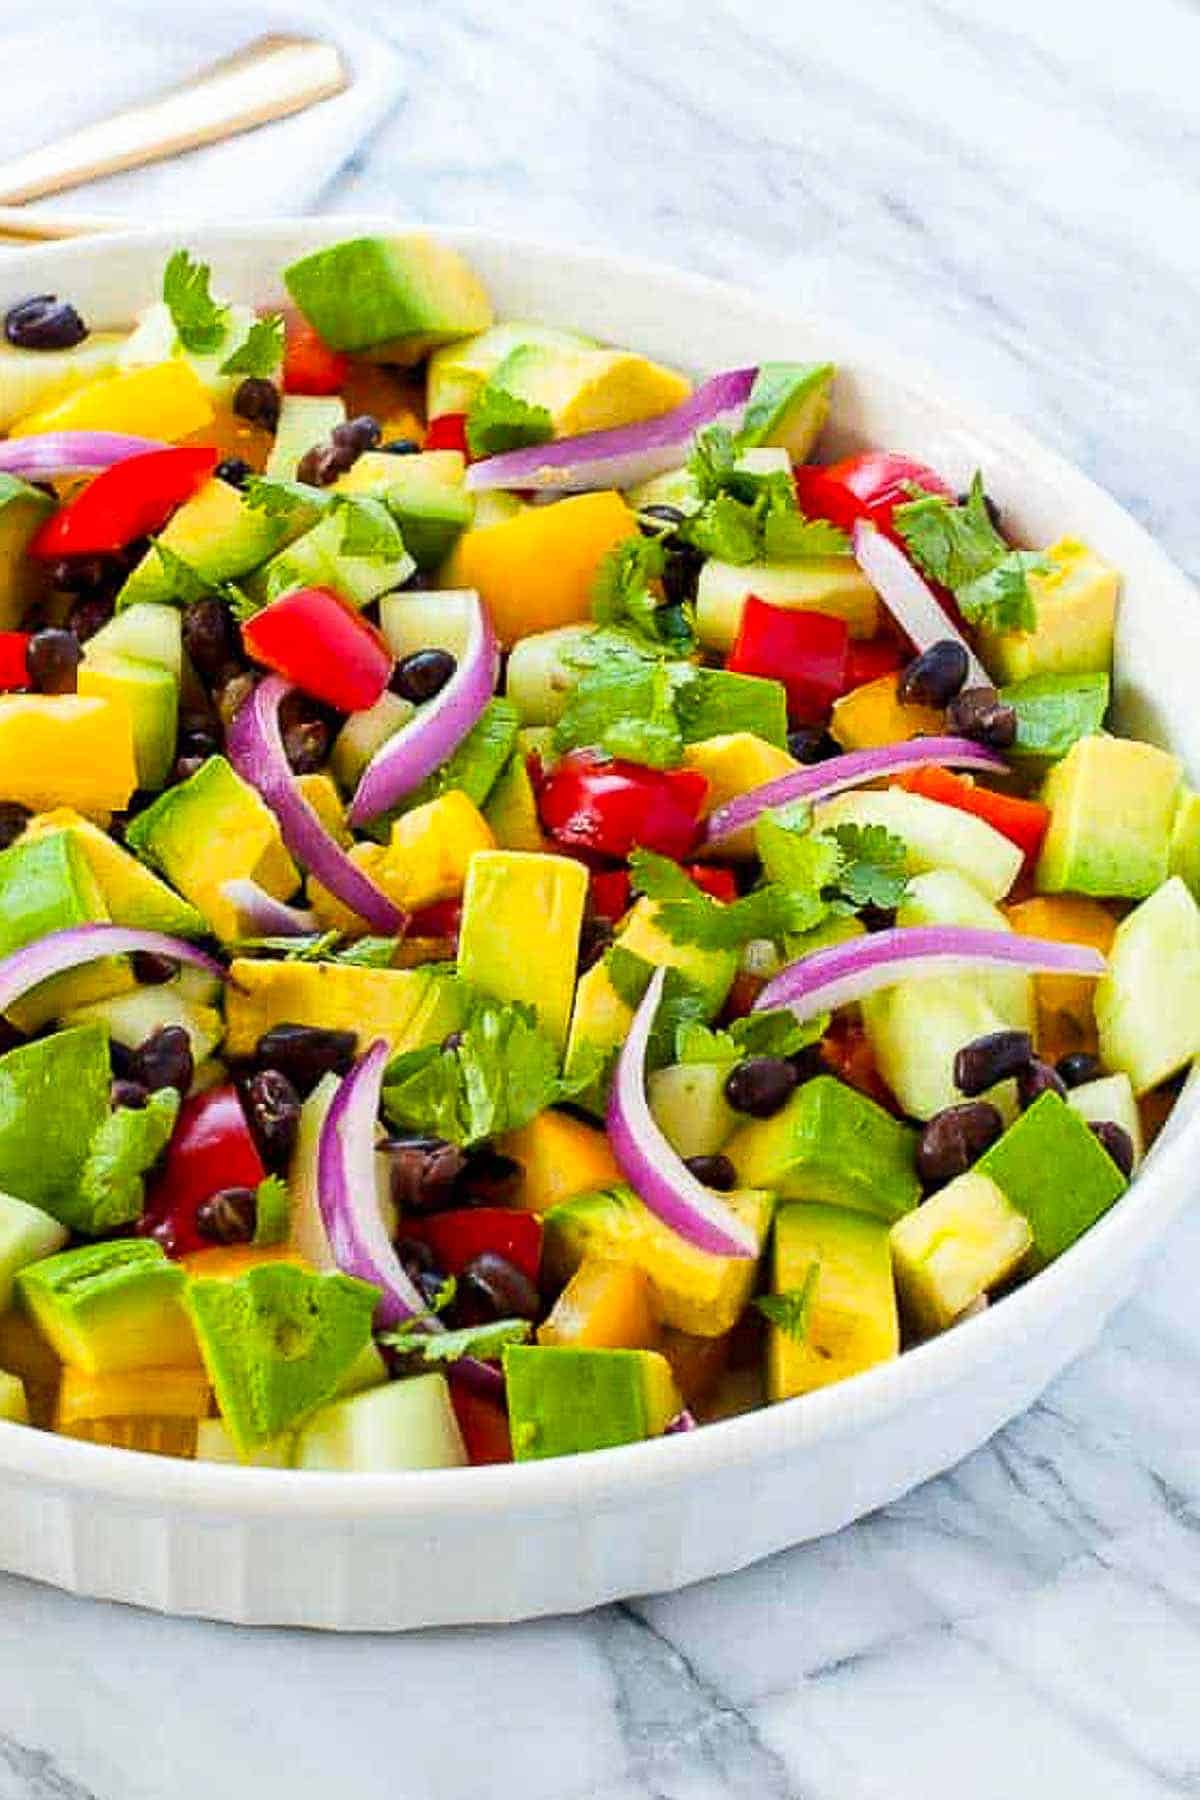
xmin=441 ymin=490 xmax=637 ymax=650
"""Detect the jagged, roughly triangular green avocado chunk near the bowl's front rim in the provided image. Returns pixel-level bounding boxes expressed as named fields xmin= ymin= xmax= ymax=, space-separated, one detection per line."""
xmin=185 ymin=1262 xmax=380 ymax=1453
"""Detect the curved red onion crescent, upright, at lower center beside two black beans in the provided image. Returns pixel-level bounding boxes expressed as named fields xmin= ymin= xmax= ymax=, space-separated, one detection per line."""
xmin=608 ymin=968 xmax=759 ymax=1256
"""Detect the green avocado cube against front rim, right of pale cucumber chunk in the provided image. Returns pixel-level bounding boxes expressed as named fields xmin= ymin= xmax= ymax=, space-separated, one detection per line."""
xmin=504 ymin=1345 xmax=684 ymax=1462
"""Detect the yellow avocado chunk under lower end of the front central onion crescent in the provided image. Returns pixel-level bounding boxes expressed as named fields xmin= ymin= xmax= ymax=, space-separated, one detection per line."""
xmin=542 ymin=1186 xmax=772 ymax=1337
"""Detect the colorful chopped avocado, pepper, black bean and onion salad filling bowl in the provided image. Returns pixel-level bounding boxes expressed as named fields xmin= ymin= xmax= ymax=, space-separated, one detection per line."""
xmin=0 ymin=234 xmax=1200 ymax=1472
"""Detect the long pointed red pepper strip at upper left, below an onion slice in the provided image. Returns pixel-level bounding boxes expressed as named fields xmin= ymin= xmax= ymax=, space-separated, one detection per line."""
xmin=29 ymin=445 xmax=219 ymax=562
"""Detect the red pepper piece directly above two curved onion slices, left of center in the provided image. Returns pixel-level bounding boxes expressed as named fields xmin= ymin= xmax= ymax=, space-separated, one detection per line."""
xmin=241 ymin=587 xmax=394 ymax=713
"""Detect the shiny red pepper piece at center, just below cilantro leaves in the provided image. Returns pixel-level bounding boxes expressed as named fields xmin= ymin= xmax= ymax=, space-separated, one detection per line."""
xmin=538 ymin=751 xmax=709 ymax=862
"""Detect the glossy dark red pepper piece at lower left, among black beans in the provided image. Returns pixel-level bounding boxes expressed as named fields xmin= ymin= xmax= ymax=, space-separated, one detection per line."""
xmin=137 ymin=1082 xmax=266 ymax=1256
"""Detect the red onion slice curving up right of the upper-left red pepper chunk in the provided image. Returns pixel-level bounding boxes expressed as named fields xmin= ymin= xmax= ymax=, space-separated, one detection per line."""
xmin=347 ymin=594 xmax=500 ymax=824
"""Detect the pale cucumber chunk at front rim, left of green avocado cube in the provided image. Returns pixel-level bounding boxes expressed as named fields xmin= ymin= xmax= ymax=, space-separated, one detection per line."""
xmin=293 ymin=1373 xmax=468 ymax=1474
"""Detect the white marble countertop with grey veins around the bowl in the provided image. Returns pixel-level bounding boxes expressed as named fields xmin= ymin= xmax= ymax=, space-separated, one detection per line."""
xmin=0 ymin=0 xmax=1200 ymax=1800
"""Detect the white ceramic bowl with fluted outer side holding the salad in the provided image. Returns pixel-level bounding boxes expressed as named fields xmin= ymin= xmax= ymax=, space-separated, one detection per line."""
xmin=0 ymin=218 xmax=1200 ymax=1631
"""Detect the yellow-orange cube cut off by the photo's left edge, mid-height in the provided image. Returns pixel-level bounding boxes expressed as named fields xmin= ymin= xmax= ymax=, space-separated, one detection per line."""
xmin=0 ymin=693 xmax=137 ymax=817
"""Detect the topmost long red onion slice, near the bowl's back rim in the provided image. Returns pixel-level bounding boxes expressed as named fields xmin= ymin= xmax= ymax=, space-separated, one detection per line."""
xmin=466 ymin=369 xmax=757 ymax=493
